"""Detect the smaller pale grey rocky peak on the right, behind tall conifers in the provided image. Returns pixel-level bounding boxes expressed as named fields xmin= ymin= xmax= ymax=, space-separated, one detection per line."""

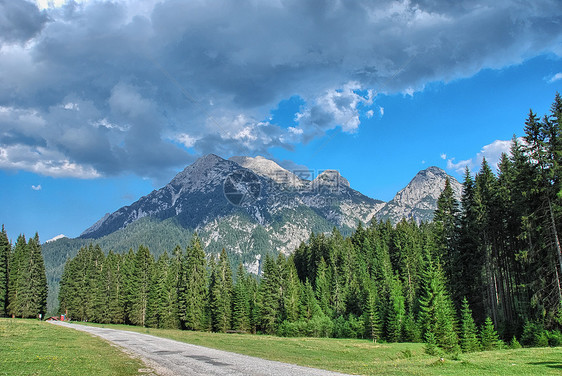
xmin=376 ymin=166 xmax=462 ymax=223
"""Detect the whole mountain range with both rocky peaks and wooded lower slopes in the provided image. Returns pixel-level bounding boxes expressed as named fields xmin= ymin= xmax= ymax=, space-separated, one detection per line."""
xmin=43 ymin=154 xmax=461 ymax=312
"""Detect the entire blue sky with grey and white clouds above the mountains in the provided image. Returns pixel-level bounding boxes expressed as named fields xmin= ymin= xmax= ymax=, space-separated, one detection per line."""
xmin=0 ymin=0 xmax=562 ymax=241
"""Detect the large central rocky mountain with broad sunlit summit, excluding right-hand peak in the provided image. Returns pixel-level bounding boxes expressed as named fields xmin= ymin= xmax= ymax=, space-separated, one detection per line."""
xmin=80 ymin=154 xmax=384 ymax=262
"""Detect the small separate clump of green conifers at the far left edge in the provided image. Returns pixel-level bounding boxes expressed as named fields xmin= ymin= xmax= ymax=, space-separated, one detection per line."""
xmin=0 ymin=225 xmax=47 ymax=318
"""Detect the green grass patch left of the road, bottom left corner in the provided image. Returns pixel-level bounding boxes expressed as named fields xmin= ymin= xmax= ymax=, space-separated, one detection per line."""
xmin=0 ymin=319 xmax=146 ymax=376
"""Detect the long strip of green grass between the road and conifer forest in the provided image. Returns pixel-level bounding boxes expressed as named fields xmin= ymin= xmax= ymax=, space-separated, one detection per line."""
xmin=79 ymin=324 xmax=562 ymax=376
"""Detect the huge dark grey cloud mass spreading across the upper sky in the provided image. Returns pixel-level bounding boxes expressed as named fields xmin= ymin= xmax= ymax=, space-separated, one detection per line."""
xmin=0 ymin=0 xmax=562 ymax=178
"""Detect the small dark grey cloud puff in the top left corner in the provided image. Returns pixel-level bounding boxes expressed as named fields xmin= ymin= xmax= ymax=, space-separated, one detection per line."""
xmin=0 ymin=0 xmax=47 ymax=43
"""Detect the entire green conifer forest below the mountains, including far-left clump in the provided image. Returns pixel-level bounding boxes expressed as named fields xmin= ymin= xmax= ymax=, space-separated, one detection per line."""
xmin=0 ymin=94 xmax=562 ymax=353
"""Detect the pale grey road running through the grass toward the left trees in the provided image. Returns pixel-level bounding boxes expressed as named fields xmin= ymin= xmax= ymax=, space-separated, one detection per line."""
xmin=54 ymin=322 xmax=350 ymax=376
